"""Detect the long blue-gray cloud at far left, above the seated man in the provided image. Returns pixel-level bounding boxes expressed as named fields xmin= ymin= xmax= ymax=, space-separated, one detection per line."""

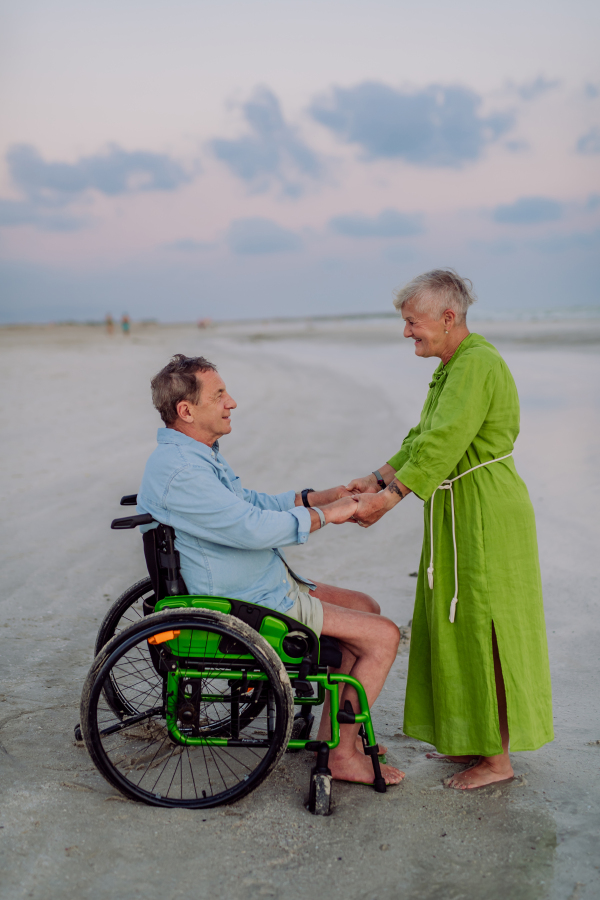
xmin=6 ymin=144 xmax=191 ymax=203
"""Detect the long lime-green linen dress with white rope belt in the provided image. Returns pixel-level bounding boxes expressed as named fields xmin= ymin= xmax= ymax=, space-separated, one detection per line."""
xmin=389 ymin=334 xmax=554 ymax=756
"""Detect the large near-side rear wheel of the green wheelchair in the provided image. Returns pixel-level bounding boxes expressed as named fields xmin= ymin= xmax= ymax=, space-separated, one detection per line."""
xmin=81 ymin=609 xmax=294 ymax=809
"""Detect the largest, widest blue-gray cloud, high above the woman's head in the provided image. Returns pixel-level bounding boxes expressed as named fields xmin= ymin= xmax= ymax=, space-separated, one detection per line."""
xmin=310 ymin=81 xmax=513 ymax=167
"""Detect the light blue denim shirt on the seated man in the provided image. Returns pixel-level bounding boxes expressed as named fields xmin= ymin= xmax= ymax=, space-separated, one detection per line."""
xmin=138 ymin=428 xmax=314 ymax=612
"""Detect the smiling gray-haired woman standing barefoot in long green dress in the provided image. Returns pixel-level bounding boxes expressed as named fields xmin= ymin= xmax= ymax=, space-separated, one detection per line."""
xmin=348 ymin=270 xmax=553 ymax=789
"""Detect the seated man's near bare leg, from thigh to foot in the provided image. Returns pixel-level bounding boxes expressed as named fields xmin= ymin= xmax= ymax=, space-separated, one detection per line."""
xmin=314 ymin=600 xmax=404 ymax=784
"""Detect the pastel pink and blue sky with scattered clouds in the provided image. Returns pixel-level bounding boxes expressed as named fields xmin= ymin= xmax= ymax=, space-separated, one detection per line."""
xmin=0 ymin=0 xmax=600 ymax=322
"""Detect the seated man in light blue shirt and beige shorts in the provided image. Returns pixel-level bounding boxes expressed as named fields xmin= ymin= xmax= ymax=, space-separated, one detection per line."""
xmin=138 ymin=354 xmax=404 ymax=784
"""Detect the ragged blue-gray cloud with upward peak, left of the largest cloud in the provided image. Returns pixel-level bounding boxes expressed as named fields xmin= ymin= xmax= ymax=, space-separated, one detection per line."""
xmin=210 ymin=88 xmax=323 ymax=197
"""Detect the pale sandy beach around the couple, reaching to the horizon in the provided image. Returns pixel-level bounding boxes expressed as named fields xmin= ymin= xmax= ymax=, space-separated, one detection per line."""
xmin=0 ymin=318 xmax=600 ymax=900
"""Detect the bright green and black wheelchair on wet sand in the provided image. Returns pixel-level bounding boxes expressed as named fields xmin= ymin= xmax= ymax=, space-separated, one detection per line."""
xmin=75 ymin=494 xmax=386 ymax=815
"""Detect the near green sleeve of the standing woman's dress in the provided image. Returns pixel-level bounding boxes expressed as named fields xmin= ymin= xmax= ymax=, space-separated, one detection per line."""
xmin=391 ymin=352 xmax=496 ymax=500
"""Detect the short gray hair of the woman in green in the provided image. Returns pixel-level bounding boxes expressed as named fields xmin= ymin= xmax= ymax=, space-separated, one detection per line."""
xmin=394 ymin=269 xmax=477 ymax=325
